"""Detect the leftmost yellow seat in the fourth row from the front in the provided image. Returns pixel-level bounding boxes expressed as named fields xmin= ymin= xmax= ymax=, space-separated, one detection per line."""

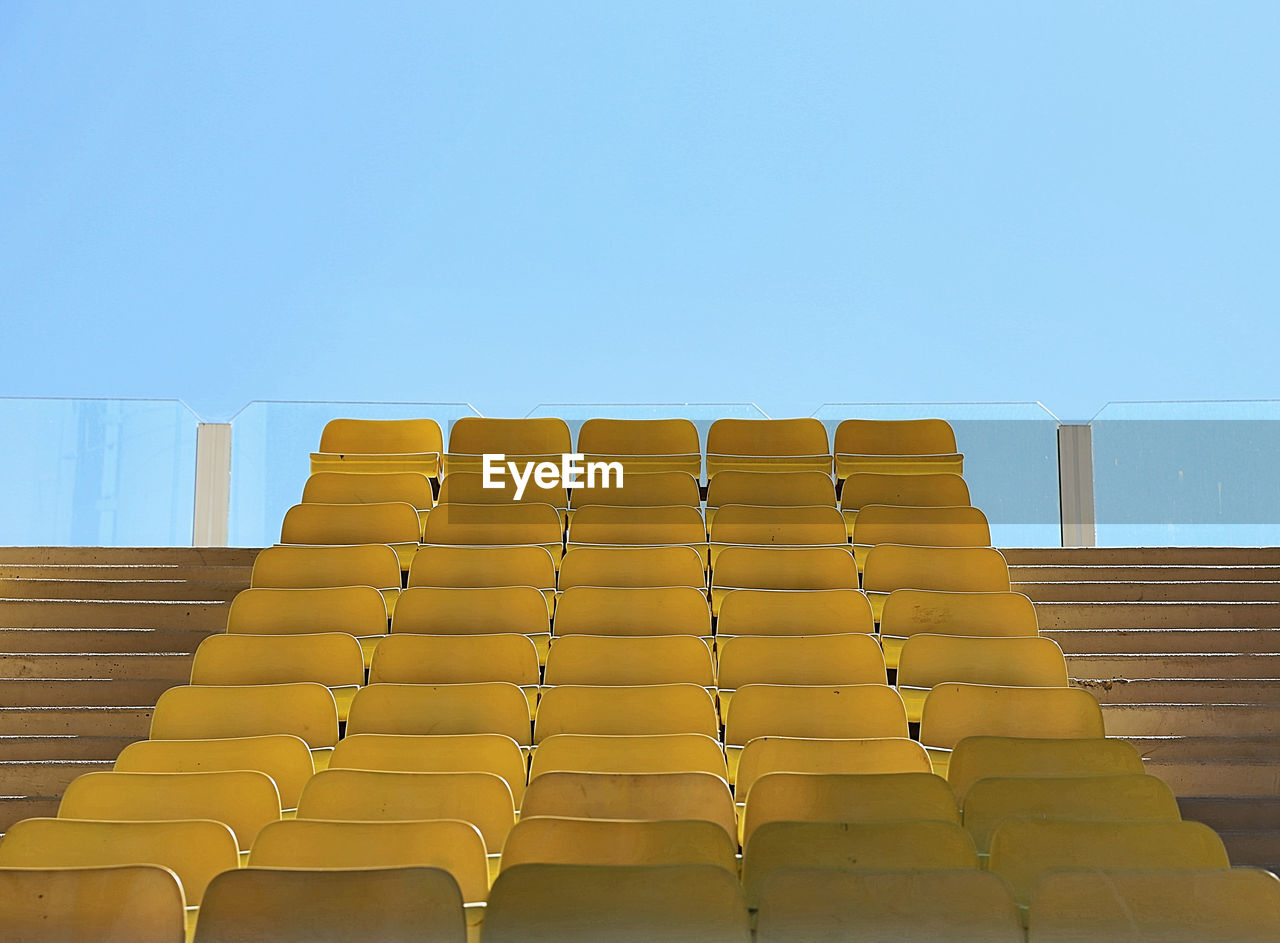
xmin=113 ymin=733 xmax=315 ymax=810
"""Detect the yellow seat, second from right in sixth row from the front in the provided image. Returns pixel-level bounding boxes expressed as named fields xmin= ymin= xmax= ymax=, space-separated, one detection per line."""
xmin=716 ymin=635 xmax=887 ymax=710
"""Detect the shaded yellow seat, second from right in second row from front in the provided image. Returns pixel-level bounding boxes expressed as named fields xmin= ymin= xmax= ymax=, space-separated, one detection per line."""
xmin=742 ymin=819 xmax=978 ymax=911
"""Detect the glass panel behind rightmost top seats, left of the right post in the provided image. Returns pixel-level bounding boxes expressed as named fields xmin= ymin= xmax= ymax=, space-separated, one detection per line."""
xmin=814 ymin=403 xmax=1062 ymax=546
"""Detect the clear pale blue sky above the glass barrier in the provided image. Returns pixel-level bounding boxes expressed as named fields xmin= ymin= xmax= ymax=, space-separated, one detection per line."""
xmin=0 ymin=0 xmax=1280 ymax=418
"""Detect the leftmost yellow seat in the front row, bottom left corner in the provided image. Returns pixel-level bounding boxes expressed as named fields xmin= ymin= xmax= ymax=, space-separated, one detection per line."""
xmin=0 ymin=865 xmax=187 ymax=943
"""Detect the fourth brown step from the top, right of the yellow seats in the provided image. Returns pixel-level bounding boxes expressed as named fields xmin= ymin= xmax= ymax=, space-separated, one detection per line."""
xmin=1036 ymin=601 xmax=1280 ymax=630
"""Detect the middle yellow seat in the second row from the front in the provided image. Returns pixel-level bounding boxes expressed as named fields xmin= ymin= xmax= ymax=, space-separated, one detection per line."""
xmin=502 ymin=815 xmax=737 ymax=876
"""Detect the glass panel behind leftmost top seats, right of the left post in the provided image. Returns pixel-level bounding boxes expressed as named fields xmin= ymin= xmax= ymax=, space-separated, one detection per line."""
xmin=229 ymin=400 xmax=480 ymax=546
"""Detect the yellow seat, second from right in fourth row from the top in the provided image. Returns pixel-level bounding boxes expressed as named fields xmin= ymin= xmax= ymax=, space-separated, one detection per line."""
xmin=712 ymin=545 xmax=858 ymax=614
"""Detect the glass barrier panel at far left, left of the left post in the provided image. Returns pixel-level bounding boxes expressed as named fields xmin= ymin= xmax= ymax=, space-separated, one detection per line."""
xmin=0 ymin=398 xmax=198 ymax=546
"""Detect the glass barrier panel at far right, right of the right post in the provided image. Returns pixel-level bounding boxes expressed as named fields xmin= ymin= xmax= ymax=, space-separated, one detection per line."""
xmin=1089 ymin=400 xmax=1280 ymax=546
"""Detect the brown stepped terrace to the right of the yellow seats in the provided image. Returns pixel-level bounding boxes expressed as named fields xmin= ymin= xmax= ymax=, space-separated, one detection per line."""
xmin=1005 ymin=548 xmax=1280 ymax=870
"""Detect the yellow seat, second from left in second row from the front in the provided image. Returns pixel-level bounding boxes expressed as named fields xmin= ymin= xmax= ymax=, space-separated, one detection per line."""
xmin=248 ymin=819 xmax=489 ymax=906
